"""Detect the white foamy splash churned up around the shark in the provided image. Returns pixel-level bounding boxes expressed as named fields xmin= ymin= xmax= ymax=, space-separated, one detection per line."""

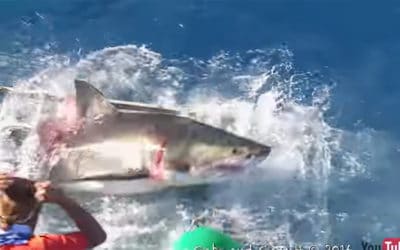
xmin=0 ymin=45 xmax=370 ymax=249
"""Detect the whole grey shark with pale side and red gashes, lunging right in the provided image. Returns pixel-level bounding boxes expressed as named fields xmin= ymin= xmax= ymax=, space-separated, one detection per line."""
xmin=15 ymin=80 xmax=271 ymax=193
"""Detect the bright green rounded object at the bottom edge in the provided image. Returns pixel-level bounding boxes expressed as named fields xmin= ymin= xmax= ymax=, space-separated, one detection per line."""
xmin=173 ymin=226 xmax=242 ymax=250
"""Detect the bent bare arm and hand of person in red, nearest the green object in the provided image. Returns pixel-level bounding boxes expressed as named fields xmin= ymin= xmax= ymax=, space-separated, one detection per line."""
xmin=35 ymin=182 xmax=107 ymax=248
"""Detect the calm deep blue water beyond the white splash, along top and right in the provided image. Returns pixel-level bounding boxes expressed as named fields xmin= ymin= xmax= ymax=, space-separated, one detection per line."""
xmin=0 ymin=0 xmax=400 ymax=249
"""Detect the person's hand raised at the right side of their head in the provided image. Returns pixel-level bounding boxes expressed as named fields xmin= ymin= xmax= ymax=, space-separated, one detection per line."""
xmin=35 ymin=181 xmax=65 ymax=203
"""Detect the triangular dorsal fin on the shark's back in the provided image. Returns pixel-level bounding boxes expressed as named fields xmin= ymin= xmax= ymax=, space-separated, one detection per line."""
xmin=75 ymin=80 xmax=117 ymax=119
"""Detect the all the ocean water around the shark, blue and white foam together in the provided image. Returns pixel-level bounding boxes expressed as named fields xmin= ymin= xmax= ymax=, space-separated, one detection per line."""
xmin=0 ymin=0 xmax=400 ymax=249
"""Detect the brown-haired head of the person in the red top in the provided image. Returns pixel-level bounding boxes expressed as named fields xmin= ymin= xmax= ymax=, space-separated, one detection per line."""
xmin=0 ymin=177 xmax=38 ymax=229
